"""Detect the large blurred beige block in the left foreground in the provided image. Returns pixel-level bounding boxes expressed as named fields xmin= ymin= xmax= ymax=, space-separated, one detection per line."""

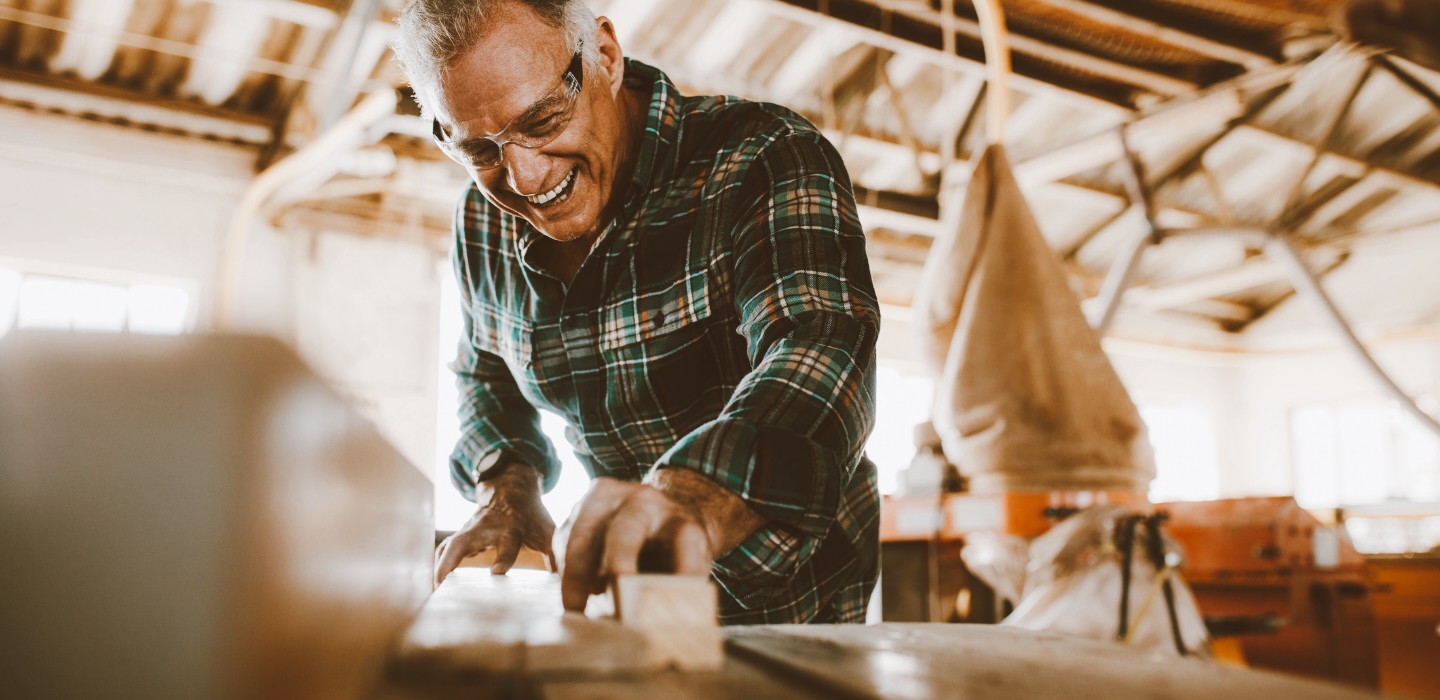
xmin=0 ymin=333 xmax=433 ymax=700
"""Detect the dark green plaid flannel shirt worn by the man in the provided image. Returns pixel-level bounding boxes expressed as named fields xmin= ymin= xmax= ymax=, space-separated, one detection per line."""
xmin=451 ymin=60 xmax=880 ymax=624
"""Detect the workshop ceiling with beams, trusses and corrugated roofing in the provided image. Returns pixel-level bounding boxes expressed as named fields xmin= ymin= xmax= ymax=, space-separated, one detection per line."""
xmin=0 ymin=0 xmax=1440 ymax=349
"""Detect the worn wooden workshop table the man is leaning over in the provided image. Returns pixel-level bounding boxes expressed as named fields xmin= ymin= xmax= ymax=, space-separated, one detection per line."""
xmin=376 ymin=569 xmax=1377 ymax=700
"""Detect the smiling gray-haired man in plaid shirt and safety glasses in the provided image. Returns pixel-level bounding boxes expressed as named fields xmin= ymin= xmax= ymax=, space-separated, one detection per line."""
xmin=397 ymin=0 xmax=880 ymax=624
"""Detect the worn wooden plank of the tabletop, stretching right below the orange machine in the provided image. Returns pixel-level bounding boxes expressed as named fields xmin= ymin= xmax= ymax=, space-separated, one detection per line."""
xmin=726 ymin=624 xmax=1380 ymax=700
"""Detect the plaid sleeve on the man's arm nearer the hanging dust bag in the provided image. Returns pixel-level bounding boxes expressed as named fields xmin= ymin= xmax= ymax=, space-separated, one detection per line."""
xmin=655 ymin=133 xmax=880 ymax=585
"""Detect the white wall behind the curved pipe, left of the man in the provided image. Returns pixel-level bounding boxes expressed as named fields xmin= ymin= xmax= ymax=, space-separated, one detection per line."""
xmin=0 ymin=105 xmax=439 ymax=475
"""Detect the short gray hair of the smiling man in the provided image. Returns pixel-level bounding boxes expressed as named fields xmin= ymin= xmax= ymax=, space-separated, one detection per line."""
xmin=395 ymin=0 xmax=599 ymax=104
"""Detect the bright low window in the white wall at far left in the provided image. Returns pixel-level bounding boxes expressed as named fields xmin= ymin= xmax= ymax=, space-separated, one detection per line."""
xmin=0 ymin=269 xmax=192 ymax=336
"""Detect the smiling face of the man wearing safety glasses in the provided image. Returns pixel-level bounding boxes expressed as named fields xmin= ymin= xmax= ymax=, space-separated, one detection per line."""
xmin=426 ymin=3 xmax=638 ymax=242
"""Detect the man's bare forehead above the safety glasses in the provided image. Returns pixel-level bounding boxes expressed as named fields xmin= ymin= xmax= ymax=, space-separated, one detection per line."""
xmin=432 ymin=3 xmax=570 ymax=133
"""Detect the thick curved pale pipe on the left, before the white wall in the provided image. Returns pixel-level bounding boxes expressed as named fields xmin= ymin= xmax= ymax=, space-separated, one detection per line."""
xmin=215 ymin=88 xmax=399 ymax=333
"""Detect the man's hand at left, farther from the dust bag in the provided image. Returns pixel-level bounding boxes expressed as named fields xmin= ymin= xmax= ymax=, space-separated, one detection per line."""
xmin=435 ymin=462 xmax=556 ymax=588
